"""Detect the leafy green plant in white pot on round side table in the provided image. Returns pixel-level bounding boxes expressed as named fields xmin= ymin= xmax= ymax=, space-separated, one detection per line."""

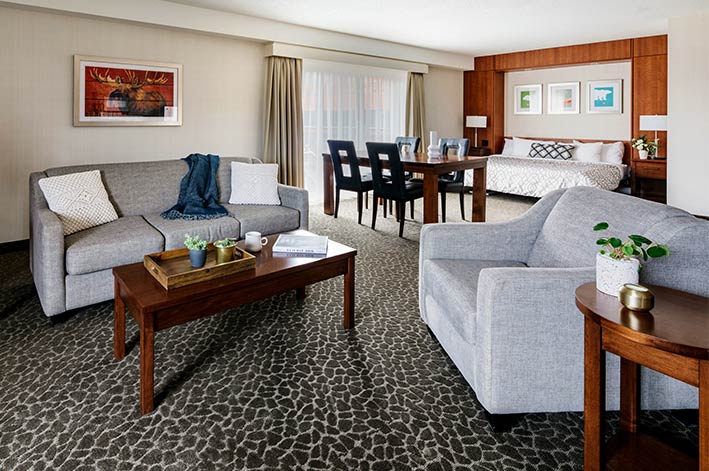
xmin=593 ymin=222 xmax=670 ymax=297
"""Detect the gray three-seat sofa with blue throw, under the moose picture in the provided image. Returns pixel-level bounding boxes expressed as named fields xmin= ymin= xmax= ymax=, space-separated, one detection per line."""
xmin=30 ymin=157 xmax=308 ymax=316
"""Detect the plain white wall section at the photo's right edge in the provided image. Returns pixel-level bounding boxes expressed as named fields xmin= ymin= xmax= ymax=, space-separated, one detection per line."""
xmin=667 ymin=14 xmax=709 ymax=216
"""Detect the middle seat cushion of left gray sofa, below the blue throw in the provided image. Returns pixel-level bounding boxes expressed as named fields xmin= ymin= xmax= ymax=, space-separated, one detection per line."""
xmin=144 ymin=214 xmax=239 ymax=250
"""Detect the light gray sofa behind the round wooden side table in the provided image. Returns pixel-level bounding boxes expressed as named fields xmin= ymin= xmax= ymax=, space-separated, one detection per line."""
xmin=419 ymin=187 xmax=709 ymax=415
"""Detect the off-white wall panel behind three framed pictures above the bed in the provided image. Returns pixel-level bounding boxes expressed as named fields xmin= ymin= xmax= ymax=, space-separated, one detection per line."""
xmin=505 ymin=62 xmax=632 ymax=140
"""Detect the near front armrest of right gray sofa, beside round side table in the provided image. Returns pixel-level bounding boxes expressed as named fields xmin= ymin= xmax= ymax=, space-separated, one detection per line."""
xmin=473 ymin=267 xmax=595 ymax=414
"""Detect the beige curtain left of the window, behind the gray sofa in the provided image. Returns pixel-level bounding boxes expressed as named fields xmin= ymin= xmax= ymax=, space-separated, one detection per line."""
xmin=263 ymin=56 xmax=303 ymax=188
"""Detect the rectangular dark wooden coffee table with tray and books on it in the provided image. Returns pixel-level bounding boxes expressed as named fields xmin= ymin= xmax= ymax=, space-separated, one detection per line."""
xmin=113 ymin=231 xmax=357 ymax=414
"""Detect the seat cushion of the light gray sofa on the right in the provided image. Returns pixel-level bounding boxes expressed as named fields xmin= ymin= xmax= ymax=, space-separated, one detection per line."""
xmin=423 ymin=259 xmax=525 ymax=341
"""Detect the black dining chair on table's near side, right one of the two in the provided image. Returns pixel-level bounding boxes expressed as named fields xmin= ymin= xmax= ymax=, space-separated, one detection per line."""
xmin=367 ymin=142 xmax=423 ymax=237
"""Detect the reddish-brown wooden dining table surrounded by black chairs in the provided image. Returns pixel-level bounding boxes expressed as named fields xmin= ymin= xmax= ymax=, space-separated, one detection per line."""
xmin=322 ymin=152 xmax=487 ymax=224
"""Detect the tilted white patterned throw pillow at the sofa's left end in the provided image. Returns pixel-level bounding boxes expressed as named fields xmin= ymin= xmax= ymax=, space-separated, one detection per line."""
xmin=38 ymin=170 xmax=118 ymax=235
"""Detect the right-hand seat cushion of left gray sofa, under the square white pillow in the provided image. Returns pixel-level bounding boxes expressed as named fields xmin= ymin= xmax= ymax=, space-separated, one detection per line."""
xmin=224 ymin=204 xmax=300 ymax=237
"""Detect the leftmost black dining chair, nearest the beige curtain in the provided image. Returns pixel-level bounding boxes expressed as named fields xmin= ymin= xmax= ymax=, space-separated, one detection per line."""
xmin=327 ymin=140 xmax=376 ymax=224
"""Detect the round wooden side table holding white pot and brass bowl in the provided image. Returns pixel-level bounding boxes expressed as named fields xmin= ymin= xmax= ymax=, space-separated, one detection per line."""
xmin=576 ymin=283 xmax=709 ymax=471
